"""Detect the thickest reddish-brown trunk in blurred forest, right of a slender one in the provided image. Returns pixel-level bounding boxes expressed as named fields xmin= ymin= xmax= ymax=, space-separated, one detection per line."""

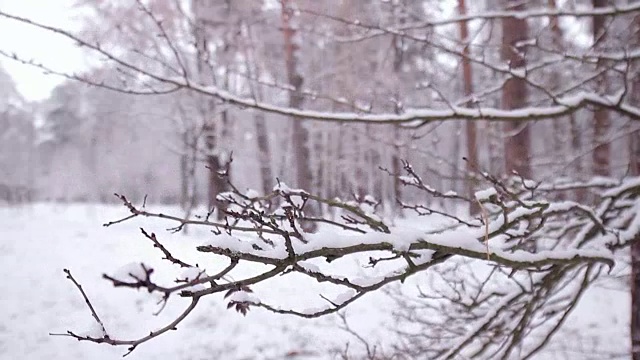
xmin=501 ymin=0 xmax=531 ymax=178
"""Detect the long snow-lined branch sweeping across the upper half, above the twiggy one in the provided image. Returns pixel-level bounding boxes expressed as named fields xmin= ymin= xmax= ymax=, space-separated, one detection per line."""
xmin=0 ymin=9 xmax=640 ymax=127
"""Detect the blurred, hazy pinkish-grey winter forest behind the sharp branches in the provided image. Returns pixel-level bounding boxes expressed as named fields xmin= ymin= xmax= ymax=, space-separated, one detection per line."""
xmin=0 ymin=0 xmax=640 ymax=214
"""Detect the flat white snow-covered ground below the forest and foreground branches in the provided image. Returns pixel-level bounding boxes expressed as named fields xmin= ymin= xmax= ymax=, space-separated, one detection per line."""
xmin=0 ymin=204 xmax=629 ymax=360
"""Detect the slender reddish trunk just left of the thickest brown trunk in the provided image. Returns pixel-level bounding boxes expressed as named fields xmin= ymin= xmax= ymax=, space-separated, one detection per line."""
xmin=458 ymin=0 xmax=480 ymax=214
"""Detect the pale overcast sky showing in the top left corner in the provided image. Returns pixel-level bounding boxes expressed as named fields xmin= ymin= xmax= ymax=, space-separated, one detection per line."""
xmin=0 ymin=0 xmax=84 ymax=100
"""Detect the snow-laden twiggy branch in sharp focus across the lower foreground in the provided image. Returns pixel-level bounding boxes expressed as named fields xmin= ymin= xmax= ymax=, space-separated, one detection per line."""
xmin=51 ymin=162 xmax=640 ymax=358
